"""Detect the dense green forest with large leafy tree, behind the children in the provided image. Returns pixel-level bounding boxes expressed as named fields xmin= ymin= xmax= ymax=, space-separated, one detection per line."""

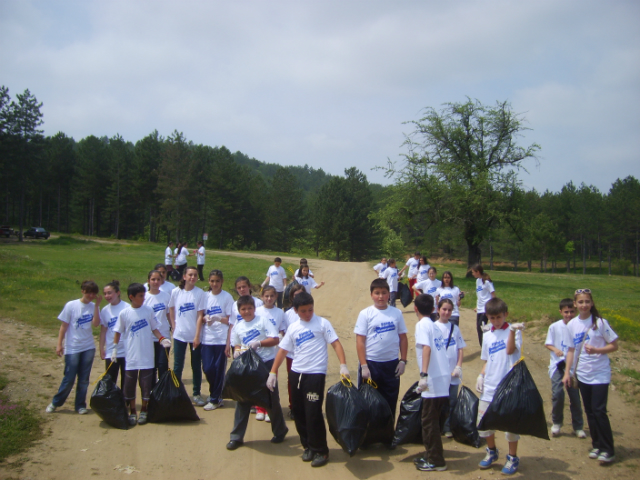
xmin=0 ymin=86 xmax=640 ymax=276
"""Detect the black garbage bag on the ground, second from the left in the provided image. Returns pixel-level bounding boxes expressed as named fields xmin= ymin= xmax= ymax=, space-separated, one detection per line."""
xmin=148 ymin=370 xmax=200 ymax=423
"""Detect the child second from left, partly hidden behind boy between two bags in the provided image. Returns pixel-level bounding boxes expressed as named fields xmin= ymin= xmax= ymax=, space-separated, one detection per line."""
xmin=99 ymin=280 xmax=129 ymax=390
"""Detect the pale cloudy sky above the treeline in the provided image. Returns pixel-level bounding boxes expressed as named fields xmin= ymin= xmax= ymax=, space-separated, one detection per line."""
xmin=0 ymin=0 xmax=640 ymax=192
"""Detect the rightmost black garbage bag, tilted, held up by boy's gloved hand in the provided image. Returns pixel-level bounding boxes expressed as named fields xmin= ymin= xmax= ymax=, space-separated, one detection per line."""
xmin=478 ymin=360 xmax=549 ymax=440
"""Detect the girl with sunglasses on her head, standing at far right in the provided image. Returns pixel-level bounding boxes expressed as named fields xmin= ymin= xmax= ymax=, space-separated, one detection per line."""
xmin=562 ymin=288 xmax=618 ymax=465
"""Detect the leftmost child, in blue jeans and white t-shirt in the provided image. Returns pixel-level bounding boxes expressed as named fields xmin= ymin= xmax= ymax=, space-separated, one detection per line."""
xmin=46 ymin=280 xmax=102 ymax=415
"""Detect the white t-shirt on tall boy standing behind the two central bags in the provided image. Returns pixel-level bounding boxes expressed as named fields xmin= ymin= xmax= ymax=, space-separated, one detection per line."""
xmin=353 ymin=305 xmax=407 ymax=362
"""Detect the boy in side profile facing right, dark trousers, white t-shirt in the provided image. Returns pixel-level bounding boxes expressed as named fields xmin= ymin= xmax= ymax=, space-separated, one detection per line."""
xmin=413 ymin=293 xmax=451 ymax=472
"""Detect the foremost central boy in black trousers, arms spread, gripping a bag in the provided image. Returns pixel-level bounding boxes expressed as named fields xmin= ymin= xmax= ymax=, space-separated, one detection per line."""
xmin=267 ymin=292 xmax=349 ymax=467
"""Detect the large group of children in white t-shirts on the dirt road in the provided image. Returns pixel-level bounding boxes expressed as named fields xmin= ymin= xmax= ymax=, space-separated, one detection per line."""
xmin=47 ymin=254 xmax=617 ymax=475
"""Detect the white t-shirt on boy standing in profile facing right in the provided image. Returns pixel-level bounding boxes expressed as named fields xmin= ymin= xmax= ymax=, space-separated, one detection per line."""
xmin=416 ymin=317 xmax=451 ymax=398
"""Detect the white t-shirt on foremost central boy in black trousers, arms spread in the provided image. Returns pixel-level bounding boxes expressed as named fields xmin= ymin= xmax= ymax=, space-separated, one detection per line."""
xmin=280 ymin=314 xmax=338 ymax=375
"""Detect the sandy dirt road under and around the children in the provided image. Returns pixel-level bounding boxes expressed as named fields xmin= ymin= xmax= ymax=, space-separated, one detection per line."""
xmin=0 ymin=255 xmax=640 ymax=480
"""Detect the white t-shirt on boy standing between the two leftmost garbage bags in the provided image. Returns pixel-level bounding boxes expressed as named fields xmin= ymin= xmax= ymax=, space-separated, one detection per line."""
xmin=115 ymin=305 xmax=158 ymax=370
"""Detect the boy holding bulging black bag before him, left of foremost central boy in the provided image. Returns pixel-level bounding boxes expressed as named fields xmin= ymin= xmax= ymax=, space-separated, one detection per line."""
xmin=227 ymin=295 xmax=289 ymax=450
